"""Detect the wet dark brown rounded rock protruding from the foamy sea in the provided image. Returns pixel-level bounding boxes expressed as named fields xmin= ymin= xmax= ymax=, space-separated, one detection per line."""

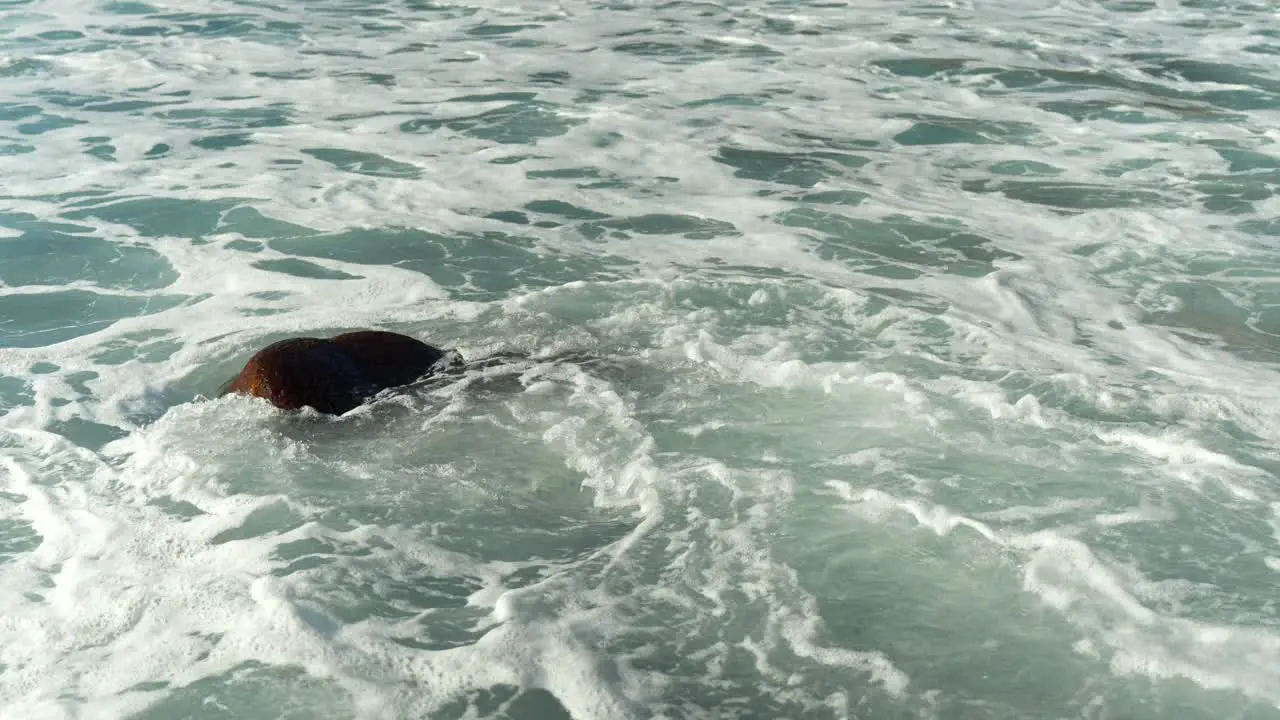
xmin=224 ymin=331 xmax=460 ymax=415
